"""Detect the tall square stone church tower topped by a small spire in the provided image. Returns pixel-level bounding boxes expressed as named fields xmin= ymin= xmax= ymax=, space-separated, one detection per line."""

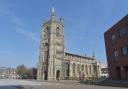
xmin=37 ymin=8 xmax=64 ymax=80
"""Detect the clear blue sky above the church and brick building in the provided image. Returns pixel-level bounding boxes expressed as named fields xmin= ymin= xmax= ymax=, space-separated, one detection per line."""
xmin=0 ymin=0 xmax=128 ymax=67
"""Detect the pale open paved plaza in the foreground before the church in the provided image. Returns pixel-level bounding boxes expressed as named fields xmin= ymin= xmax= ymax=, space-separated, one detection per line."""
xmin=0 ymin=79 xmax=126 ymax=89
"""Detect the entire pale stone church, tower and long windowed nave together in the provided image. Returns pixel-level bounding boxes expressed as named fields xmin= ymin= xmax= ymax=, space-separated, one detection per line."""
xmin=37 ymin=8 xmax=100 ymax=80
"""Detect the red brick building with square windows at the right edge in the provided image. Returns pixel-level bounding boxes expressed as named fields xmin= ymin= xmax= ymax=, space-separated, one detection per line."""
xmin=104 ymin=15 xmax=128 ymax=80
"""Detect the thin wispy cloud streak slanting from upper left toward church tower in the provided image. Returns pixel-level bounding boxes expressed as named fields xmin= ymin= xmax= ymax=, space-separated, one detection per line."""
xmin=0 ymin=2 xmax=38 ymax=42
